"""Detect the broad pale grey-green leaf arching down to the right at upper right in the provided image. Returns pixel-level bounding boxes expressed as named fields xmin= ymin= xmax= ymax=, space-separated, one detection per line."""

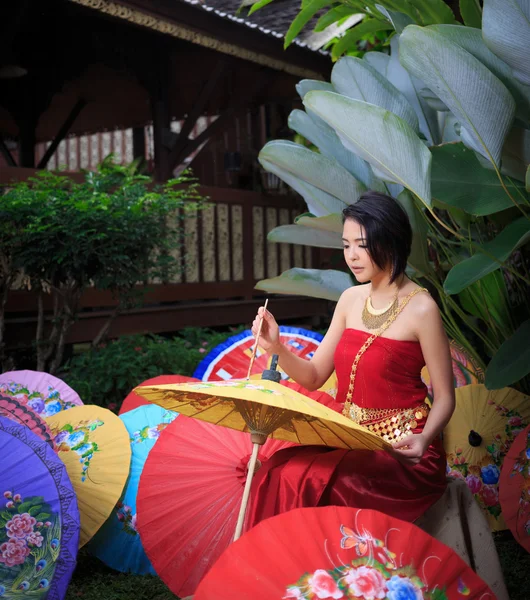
xmin=399 ymin=25 xmax=515 ymax=165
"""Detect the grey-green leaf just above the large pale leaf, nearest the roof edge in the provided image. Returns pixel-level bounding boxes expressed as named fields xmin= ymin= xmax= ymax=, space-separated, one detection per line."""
xmin=331 ymin=56 xmax=419 ymax=132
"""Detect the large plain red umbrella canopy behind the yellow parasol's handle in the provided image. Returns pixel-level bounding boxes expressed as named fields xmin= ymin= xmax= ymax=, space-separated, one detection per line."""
xmin=138 ymin=416 xmax=292 ymax=596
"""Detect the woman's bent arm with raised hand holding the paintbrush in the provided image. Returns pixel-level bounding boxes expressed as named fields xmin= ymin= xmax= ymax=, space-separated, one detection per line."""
xmin=252 ymin=288 xmax=354 ymax=391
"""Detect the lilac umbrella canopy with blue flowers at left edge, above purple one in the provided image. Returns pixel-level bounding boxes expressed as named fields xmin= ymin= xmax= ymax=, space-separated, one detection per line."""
xmin=0 ymin=371 xmax=83 ymax=417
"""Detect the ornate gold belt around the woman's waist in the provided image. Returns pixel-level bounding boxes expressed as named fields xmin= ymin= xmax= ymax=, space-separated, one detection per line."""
xmin=347 ymin=402 xmax=430 ymax=443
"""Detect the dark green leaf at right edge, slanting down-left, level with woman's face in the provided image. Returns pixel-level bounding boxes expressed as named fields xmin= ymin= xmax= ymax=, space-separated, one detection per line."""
xmin=444 ymin=217 xmax=530 ymax=294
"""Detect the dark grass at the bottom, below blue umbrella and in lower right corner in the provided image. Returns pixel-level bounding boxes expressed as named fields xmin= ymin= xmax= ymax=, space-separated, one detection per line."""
xmin=66 ymin=532 xmax=530 ymax=600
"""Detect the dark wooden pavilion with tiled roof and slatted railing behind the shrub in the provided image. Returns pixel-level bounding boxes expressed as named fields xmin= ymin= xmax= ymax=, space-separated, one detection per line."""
xmin=0 ymin=0 xmax=331 ymax=350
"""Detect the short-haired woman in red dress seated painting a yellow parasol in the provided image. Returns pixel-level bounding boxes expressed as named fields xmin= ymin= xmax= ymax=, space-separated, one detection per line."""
xmin=249 ymin=191 xmax=455 ymax=526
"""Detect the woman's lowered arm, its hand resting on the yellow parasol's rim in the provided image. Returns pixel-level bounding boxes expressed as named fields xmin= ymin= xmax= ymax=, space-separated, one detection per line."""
xmin=393 ymin=295 xmax=455 ymax=464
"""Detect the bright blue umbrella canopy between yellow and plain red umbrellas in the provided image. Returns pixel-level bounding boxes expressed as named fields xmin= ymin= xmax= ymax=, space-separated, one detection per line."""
xmin=88 ymin=404 xmax=178 ymax=575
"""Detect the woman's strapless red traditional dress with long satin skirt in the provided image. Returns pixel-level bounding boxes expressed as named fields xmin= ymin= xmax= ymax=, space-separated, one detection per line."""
xmin=248 ymin=329 xmax=446 ymax=527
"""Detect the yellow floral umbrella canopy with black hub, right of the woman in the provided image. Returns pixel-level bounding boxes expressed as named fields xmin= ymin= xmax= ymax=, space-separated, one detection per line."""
xmin=444 ymin=384 xmax=530 ymax=531
